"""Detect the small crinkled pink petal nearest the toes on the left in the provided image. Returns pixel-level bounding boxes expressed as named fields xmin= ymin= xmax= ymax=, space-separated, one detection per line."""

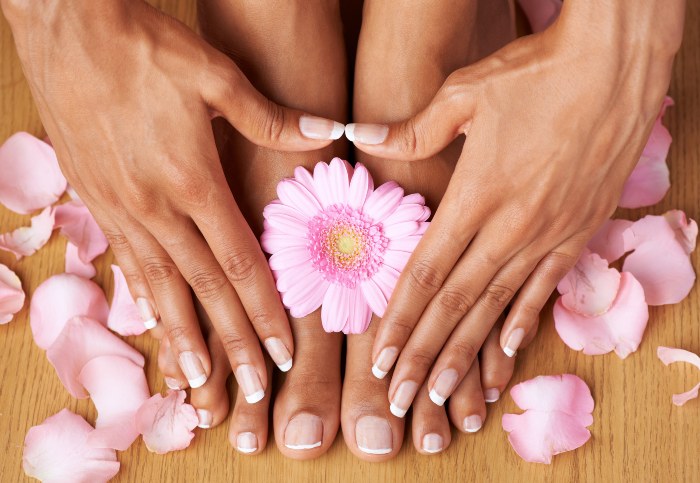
xmin=136 ymin=391 xmax=199 ymax=454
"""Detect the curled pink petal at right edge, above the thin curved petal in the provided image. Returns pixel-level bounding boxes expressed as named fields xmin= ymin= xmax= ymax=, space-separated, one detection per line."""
xmin=622 ymin=211 xmax=697 ymax=305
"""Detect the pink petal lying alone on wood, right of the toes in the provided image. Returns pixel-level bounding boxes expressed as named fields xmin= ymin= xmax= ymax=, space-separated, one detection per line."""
xmin=502 ymin=374 xmax=594 ymax=464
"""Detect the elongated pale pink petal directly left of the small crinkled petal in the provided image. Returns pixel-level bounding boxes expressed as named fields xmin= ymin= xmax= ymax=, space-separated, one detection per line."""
xmin=78 ymin=355 xmax=151 ymax=451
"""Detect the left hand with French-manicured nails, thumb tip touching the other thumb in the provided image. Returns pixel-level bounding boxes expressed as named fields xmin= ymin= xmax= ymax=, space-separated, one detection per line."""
xmin=3 ymin=0 xmax=343 ymax=402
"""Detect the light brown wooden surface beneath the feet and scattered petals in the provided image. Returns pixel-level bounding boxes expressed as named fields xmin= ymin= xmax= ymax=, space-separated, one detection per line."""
xmin=0 ymin=0 xmax=700 ymax=483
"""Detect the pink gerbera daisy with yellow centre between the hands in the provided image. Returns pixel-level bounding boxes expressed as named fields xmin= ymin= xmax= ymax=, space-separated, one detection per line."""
xmin=261 ymin=158 xmax=430 ymax=334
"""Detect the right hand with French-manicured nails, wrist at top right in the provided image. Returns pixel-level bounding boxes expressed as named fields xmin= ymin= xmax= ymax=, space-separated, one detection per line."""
xmin=347 ymin=0 xmax=683 ymax=408
